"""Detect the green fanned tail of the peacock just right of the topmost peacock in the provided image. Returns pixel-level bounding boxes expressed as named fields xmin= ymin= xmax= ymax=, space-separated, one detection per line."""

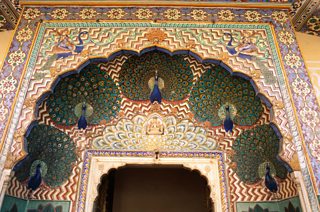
xmin=189 ymin=66 xmax=263 ymax=126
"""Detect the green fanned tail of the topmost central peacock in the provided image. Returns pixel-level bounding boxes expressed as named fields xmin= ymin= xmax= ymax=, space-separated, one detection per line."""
xmin=119 ymin=51 xmax=193 ymax=101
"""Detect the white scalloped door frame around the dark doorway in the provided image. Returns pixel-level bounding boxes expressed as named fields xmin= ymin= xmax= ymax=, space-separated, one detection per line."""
xmin=84 ymin=152 xmax=229 ymax=212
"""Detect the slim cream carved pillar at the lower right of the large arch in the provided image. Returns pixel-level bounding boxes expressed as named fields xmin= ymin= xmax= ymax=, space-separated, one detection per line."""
xmin=290 ymin=171 xmax=311 ymax=212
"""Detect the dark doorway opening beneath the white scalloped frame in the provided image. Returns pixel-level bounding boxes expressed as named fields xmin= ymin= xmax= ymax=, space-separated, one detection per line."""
xmin=94 ymin=165 xmax=213 ymax=212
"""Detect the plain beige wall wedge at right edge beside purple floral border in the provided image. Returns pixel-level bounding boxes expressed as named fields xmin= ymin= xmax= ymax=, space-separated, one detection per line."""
xmin=296 ymin=32 xmax=320 ymax=104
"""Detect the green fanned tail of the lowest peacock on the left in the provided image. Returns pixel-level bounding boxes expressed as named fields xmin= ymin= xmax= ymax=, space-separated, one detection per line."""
xmin=14 ymin=125 xmax=76 ymax=187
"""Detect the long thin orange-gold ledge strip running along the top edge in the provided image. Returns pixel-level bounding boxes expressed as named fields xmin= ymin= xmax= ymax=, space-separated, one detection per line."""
xmin=20 ymin=0 xmax=292 ymax=9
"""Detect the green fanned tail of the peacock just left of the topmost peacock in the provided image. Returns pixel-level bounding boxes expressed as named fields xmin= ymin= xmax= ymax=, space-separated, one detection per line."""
xmin=46 ymin=63 xmax=121 ymax=126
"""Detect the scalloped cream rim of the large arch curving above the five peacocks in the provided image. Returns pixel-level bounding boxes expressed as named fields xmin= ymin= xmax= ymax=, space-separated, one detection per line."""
xmin=7 ymin=46 xmax=290 ymax=167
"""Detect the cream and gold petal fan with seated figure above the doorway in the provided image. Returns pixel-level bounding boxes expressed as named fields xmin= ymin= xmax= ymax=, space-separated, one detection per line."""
xmin=92 ymin=113 xmax=217 ymax=151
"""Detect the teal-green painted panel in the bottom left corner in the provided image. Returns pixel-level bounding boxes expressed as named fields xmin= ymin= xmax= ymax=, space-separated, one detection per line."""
xmin=1 ymin=195 xmax=28 ymax=212
